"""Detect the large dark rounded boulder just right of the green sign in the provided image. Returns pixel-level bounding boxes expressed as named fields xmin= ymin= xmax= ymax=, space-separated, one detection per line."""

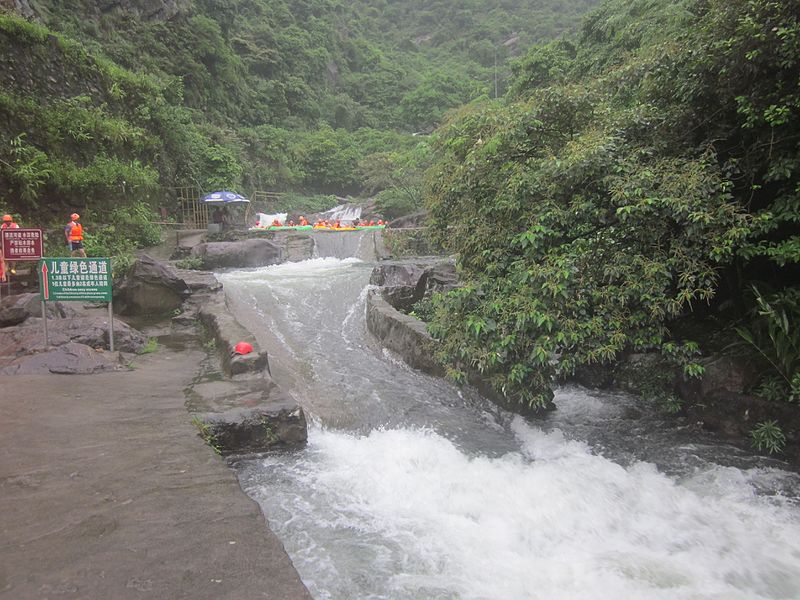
xmin=114 ymin=254 xmax=189 ymax=315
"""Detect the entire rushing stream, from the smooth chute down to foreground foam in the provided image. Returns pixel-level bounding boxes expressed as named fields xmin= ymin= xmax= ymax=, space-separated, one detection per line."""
xmin=221 ymin=258 xmax=800 ymax=600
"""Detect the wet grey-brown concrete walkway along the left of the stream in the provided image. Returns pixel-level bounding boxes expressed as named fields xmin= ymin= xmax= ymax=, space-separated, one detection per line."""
xmin=0 ymin=349 xmax=310 ymax=600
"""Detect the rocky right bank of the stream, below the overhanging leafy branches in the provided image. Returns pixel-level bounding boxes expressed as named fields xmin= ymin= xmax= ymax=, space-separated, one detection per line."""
xmin=367 ymin=257 xmax=800 ymax=465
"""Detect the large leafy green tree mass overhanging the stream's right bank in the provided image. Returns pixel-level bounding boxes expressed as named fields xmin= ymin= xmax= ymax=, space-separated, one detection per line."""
xmin=422 ymin=0 xmax=800 ymax=405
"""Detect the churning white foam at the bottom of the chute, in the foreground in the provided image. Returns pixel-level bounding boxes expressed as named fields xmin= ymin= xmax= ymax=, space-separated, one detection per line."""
xmin=255 ymin=418 xmax=800 ymax=600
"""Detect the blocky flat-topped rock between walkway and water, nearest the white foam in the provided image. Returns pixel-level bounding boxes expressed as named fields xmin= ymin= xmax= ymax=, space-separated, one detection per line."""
xmin=187 ymin=377 xmax=308 ymax=454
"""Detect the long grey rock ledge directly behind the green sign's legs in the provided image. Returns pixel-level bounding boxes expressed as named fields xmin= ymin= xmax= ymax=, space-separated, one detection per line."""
xmin=0 ymin=316 xmax=147 ymax=356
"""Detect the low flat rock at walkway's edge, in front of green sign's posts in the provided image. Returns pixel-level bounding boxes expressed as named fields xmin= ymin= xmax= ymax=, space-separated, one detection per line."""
xmin=0 ymin=342 xmax=122 ymax=375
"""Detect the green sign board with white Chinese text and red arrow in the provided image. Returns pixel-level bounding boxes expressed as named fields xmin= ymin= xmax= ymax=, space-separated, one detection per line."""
xmin=39 ymin=257 xmax=112 ymax=302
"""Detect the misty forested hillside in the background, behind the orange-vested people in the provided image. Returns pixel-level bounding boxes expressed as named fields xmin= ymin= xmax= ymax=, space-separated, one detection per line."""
xmin=0 ymin=0 xmax=592 ymax=216
